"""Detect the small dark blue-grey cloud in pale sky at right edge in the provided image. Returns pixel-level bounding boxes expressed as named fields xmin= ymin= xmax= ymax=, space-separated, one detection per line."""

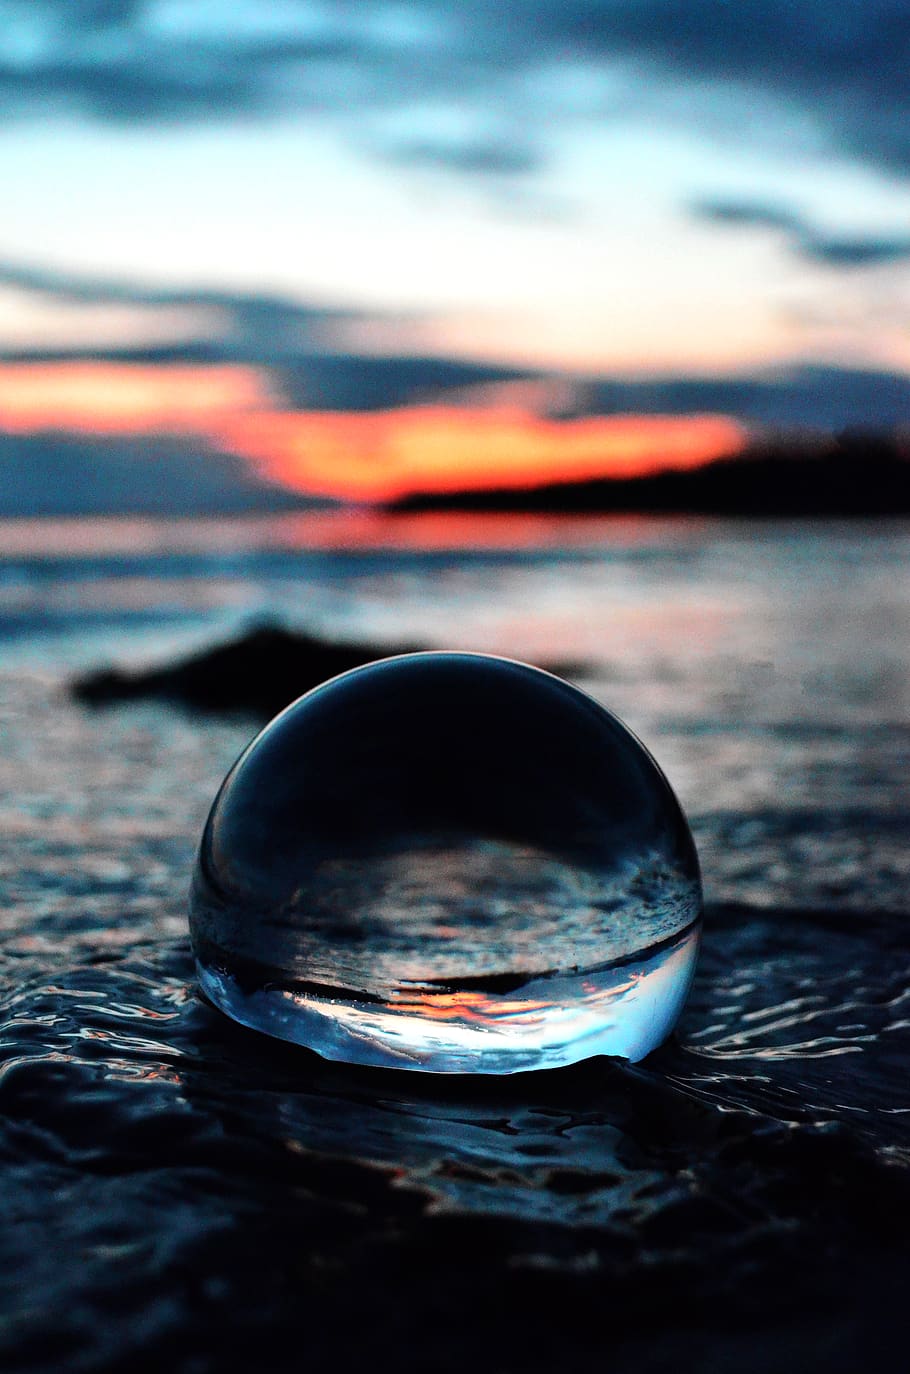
xmin=691 ymin=199 xmax=910 ymax=268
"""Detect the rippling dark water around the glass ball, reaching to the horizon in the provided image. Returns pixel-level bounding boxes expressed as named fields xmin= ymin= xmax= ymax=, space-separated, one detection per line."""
xmin=0 ymin=522 xmax=910 ymax=1370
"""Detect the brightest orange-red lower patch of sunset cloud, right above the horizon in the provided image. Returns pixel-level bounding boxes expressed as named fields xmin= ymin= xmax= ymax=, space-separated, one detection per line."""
xmin=223 ymin=405 xmax=745 ymax=500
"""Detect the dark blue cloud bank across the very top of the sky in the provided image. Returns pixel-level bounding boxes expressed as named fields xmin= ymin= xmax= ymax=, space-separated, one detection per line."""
xmin=0 ymin=0 xmax=910 ymax=185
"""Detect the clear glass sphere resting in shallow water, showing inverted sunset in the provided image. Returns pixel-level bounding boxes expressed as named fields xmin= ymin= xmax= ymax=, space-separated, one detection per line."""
xmin=190 ymin=653 xmax=701 ymax=1073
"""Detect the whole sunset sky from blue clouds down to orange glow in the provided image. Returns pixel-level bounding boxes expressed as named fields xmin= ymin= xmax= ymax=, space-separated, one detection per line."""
xmin=0 ymin=0 xmax=910 ymax=499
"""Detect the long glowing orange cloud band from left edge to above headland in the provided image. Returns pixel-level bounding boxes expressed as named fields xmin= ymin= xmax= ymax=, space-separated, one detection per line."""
xmin=0 ymin=361 xmax=745 ymax=502
